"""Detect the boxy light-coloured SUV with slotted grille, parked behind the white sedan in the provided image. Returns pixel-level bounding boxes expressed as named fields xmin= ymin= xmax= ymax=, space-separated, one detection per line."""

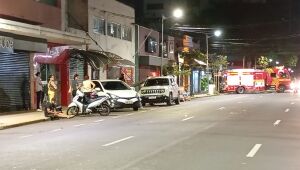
xmin=139 ymin=76 xmax=180 ymax=106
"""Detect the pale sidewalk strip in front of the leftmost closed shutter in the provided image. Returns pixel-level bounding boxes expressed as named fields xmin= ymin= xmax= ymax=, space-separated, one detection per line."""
xmin=0 ymin=112 xmax=49 ymax=130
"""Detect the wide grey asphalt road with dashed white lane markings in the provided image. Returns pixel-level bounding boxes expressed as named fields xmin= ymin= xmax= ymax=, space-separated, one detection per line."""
xmin=0 ymin=93 xmax=300 ymax=170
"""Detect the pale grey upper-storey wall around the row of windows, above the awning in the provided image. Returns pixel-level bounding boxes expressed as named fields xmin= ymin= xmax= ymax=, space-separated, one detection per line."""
xmin=88 ymin=0 xmax=135 ymax=79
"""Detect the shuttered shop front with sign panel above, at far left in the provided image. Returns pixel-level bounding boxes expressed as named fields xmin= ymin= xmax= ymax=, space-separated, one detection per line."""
xmin=0 ymin=32 xmax=46 ymax=113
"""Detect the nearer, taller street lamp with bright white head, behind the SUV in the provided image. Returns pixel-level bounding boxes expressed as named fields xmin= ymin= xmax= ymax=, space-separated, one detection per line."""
xmin=160 ymin=8 xmax=183 ymax=76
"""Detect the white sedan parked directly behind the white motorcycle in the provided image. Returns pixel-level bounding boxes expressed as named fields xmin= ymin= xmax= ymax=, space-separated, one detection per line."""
xmin=93 ymin=80 xmax=141 ymax=111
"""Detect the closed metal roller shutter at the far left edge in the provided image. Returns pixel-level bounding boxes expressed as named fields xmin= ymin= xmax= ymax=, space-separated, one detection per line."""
xmin=0 ymin=52 xmax=30 ymax=112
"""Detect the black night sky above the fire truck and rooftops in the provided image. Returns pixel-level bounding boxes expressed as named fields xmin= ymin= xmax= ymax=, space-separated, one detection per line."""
xmin=119 ymin=0 xmax=300 ymax=56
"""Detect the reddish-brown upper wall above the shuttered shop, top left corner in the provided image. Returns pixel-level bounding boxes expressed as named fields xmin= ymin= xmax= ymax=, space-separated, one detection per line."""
xmin=0 ymin=0 xmax=61 ymax=30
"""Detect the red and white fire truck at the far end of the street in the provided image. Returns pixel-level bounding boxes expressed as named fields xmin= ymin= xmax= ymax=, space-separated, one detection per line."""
xmin=223 ymin=66 xmax=291 ymax=94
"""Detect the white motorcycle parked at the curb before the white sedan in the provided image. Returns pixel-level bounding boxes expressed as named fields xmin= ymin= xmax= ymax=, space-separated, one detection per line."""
xmin=67 ymin=88 xmax=111 ymax=116
